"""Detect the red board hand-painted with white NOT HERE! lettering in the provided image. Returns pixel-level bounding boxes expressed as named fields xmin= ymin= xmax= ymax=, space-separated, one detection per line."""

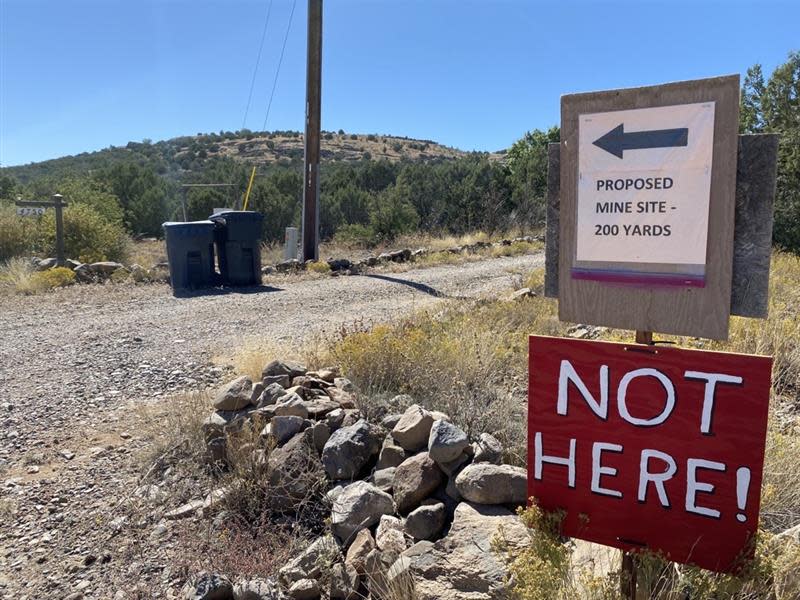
xmin=528 ymin=336 xmax=772 ymax=572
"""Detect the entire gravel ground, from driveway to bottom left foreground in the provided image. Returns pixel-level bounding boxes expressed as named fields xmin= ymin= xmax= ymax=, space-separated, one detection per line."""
xmin=0 ymin=254 xmax=544 ymax=600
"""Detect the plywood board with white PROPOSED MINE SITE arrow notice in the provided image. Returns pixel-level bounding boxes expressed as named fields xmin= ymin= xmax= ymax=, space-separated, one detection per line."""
xmin=559 ymin=76 xmax=739 ymax=339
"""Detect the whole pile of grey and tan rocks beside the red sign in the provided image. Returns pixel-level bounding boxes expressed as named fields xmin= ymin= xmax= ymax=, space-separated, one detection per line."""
xmin=191 ymin=361 xmax=529 ymax=600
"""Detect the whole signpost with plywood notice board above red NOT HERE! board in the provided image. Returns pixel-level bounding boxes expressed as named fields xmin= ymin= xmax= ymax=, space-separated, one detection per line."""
xmin=528 ymin=76 xmax=777 ymax=599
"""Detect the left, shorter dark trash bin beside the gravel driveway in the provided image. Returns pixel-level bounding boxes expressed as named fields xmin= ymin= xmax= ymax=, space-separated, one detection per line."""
xmin=162 ymin=221 xmax=216 ymax=293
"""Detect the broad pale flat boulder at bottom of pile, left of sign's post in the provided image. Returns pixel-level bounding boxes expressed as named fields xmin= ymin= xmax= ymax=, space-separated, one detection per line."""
xmin=400 ymin=502 xmax=530 ymax=600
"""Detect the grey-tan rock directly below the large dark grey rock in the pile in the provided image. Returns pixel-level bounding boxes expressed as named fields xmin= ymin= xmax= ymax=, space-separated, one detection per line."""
xmin=331 ymin=481 xmax=394 ymax=545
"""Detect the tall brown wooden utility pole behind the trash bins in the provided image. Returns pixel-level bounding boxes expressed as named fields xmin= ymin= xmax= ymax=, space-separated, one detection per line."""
xmin=303 ymin=0 xmax=322 ymax=260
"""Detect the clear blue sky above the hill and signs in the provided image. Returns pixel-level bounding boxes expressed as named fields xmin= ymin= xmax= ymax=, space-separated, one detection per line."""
xmin=0 ymin=0 xmax=800 ymax=166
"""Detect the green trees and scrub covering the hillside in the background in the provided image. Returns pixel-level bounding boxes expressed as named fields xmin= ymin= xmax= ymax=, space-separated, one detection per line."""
xmin=0 ymin=52 xmax=800 ymax=260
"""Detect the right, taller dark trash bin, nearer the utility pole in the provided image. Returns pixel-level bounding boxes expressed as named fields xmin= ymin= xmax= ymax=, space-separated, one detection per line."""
xmin=209 ymin=210 xmax=264 ymax=285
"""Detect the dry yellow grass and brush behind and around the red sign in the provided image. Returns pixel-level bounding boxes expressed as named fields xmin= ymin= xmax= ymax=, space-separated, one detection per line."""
xmin=319 ymin=253 xmax=800 ymax=531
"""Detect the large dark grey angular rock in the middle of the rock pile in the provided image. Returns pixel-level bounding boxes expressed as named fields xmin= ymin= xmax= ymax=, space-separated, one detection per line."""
xmin=322 ymin=419 xmax=383 ymax=480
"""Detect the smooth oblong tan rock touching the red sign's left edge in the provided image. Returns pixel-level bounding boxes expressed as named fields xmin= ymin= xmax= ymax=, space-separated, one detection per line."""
xmin=456 ymin=463 xmax=528 ymax=504
